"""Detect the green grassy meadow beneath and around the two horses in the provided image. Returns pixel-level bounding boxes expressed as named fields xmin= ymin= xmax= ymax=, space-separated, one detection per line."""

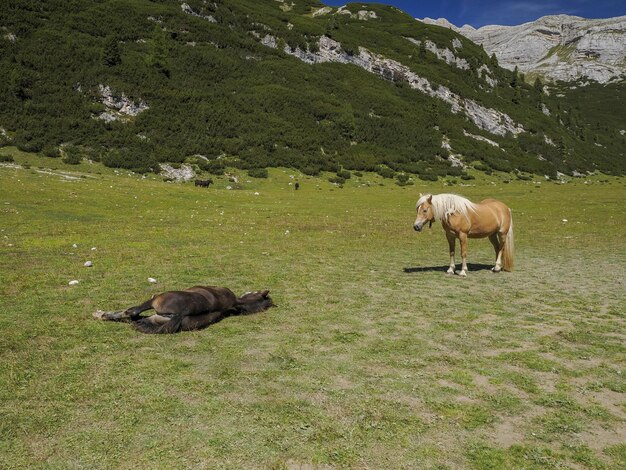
xmin=0 ymin=151 xmax=626 ymax=469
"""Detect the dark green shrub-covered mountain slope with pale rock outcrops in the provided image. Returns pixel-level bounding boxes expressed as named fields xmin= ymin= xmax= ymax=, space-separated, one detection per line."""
xmin=0 ymin=0 xmax=624 ymax=178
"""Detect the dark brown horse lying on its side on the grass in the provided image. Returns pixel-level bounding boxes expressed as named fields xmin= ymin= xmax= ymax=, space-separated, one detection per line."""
xmin=93 ymin=286 xmax=274 ymax=333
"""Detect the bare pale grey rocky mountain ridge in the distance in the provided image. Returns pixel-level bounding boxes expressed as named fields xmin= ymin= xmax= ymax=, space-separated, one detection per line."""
xmin=422 ymin=15 xmax=626 ymax=83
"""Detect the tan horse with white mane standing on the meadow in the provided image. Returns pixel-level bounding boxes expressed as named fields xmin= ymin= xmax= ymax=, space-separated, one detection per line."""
xmin=413 ymin=194 xmax=513 ymax=276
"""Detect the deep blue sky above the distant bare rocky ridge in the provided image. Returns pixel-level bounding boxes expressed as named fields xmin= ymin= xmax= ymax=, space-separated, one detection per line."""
xmin=322 ymin=0 xmax=626 ymax=28
